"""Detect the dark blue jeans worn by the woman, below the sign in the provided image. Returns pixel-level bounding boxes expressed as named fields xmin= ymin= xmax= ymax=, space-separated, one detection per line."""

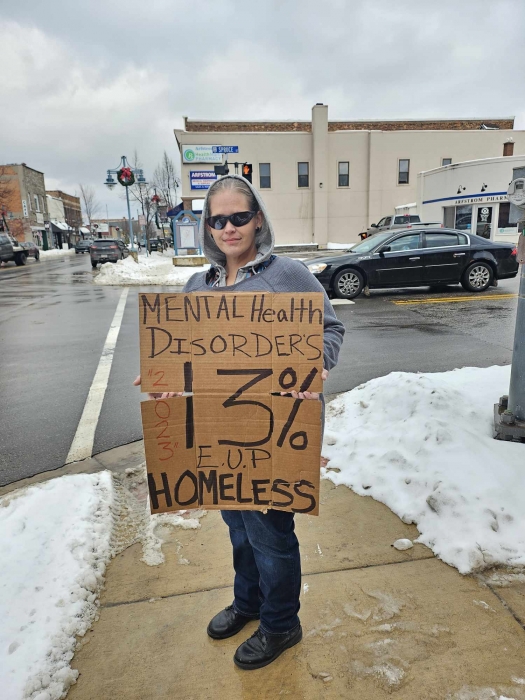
xmin=221 ymin=510 xmax=301 ymax=634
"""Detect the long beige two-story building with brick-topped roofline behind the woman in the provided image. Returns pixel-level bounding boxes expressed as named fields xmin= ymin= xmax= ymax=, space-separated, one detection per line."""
xmin=174 ymin=104 xmax=525 ymax=246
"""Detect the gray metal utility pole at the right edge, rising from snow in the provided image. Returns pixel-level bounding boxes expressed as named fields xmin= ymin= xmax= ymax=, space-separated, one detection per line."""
xmin=494 ymin=177 xmax=525 ymax=443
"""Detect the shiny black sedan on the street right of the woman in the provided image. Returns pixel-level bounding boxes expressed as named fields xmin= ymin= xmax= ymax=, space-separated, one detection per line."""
xmin=307 ymin=228 xmax=519 ymax=299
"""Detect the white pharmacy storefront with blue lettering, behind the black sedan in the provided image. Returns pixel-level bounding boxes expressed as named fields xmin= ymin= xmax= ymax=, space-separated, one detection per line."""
xmin=418 ymin=156 xmax=525 ymax=242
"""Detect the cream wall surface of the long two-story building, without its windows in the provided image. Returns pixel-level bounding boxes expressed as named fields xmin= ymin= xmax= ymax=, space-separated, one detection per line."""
xmin=175 ymin=122 xmax=525 ymax=244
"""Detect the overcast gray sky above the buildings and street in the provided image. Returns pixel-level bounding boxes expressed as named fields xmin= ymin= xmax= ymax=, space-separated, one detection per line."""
xmin=0 ymin=0 xmax=525 ymax=217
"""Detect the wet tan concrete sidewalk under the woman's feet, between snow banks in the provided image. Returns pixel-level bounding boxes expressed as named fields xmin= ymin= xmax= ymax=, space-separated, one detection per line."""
xmin=7 ymin=443 xmax=525 ymax=700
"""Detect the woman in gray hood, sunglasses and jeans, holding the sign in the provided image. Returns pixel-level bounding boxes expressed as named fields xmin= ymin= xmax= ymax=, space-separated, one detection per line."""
xmin=135 ymin=175 xmax=344 ymax=670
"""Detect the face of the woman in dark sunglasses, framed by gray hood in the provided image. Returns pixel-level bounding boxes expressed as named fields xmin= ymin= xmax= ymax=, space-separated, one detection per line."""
xmin=206 ymin=190 xmax=262 ymax=262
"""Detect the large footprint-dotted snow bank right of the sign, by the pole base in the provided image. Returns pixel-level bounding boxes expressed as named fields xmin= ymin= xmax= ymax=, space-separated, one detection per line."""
xmin=322 ymin=367 xmax=525 ymax=574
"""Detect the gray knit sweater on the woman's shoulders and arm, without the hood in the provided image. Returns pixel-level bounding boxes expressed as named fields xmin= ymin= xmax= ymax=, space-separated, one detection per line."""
xmin=184 ymin=257 xmax=345 ymax=369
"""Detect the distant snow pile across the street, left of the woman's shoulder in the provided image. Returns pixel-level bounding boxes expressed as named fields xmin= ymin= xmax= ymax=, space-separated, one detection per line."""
xmin=93 ymin=252 xmax=209 ymax=286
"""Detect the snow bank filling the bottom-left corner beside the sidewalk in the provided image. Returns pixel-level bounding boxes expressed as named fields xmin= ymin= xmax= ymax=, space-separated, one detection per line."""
xmin=0 ymin=472 xmax=113 ymax=700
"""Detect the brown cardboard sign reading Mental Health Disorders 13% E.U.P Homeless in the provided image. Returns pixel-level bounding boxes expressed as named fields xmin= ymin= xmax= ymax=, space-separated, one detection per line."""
xmin=139 ymin=292 xmax=324 ymax=515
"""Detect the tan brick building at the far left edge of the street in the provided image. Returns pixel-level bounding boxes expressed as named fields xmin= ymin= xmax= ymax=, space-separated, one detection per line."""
xmin=0 ymin=163 xmax=49 ymax=247
